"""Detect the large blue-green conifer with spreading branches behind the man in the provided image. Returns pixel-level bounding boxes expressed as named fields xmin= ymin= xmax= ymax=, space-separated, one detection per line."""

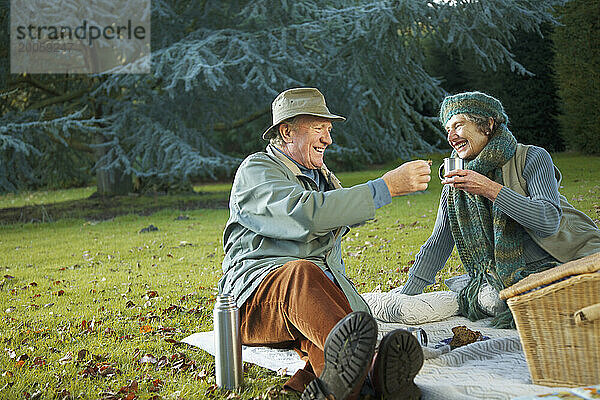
xmin=0 ymin=0 xmax=562 ymax=193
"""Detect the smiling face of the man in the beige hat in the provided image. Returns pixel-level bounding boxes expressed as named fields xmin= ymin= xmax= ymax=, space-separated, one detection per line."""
xmin=282 ymin=115 xmax=332 ymax=169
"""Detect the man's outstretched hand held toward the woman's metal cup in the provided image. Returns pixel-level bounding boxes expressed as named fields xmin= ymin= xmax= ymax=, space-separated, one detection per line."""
xmin=382 ymin=160 xmax=431 ymax=197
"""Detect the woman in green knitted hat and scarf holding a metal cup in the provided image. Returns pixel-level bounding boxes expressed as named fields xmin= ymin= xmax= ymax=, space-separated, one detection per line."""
xmin=395 ymin=92 xmax=600 ymax=327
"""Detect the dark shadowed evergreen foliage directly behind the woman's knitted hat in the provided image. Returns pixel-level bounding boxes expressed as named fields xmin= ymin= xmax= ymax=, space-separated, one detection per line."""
xmin=426 ymin=24 xmax=565 ymax=151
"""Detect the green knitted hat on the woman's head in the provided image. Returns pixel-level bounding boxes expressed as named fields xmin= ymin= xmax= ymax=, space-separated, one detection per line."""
xmin=440 ymin=92 xmax=508 ymax=126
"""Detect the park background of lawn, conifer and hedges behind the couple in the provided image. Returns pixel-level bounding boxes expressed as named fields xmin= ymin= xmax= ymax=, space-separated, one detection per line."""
xmin=0 ymin=0 xmax=600 ymax=399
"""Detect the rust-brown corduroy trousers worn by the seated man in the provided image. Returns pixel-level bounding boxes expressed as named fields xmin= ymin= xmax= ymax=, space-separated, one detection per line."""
xmin=240 ymin=260 xmax=352 ymax=392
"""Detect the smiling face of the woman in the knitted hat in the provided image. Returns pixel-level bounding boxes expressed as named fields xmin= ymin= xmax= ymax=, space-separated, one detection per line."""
xmin=446 ymin=114 xmax=490 ymax=160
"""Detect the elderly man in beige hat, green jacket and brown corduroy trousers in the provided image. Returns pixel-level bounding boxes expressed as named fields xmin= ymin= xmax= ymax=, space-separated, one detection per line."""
xmin=219 ymin=88 xmax=430 ymax=400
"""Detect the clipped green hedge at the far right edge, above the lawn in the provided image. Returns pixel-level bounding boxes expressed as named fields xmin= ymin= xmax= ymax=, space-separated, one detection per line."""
xmin=553 ymin=0 xmax=600 ymax=154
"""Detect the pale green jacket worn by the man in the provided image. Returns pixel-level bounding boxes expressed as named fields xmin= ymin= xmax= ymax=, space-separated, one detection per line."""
xmin=219 ymin=145 xmax=375 ymax=312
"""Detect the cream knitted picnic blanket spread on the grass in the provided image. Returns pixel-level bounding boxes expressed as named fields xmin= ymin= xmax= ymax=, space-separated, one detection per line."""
xmin=183 ymin=292 xmax=592 ymax=400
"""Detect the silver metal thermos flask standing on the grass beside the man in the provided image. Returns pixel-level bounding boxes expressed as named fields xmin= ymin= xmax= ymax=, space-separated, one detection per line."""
xmin=213 ymin=294 xmax=242 ymax=389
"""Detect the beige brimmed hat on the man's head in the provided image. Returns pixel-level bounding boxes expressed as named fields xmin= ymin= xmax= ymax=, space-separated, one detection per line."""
xmin=263 ymin=88 xmax=346 ymax=140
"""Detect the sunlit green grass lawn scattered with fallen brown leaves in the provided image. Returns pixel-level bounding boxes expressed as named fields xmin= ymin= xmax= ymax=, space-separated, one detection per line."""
xmin=0 ymin=154 xmax=600 ymax=399
